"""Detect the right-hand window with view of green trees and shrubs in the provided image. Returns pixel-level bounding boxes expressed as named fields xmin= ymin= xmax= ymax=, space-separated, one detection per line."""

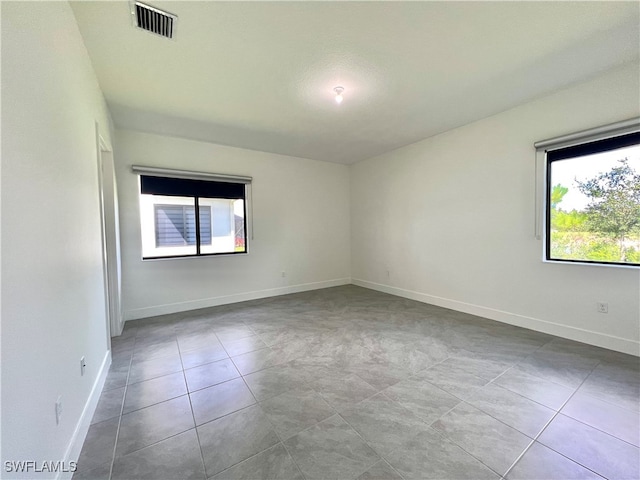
xmin=545 ymin=132 xmax=640 ymax=266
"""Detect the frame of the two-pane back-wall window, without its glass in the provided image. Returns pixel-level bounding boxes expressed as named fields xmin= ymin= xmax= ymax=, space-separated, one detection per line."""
xmin=132 ymin=165 xmax=253 ymax=261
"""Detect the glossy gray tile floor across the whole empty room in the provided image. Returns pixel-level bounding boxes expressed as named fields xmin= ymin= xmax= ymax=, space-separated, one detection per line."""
xmin=74 ymin=286 xmax=640 ymax=480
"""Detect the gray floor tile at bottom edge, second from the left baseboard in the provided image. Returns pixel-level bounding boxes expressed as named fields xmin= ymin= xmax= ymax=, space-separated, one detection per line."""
xmin=111 ymin=429 xmax=206 ymax=480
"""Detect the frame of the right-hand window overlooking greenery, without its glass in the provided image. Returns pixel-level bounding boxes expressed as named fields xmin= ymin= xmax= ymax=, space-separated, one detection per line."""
xmin=534 ymin=118 xmax=640 ymax=269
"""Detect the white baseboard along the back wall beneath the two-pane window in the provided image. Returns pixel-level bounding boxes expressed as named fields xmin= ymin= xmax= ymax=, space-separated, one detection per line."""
xmin=124 ymin=278 xmax=351 ymax=320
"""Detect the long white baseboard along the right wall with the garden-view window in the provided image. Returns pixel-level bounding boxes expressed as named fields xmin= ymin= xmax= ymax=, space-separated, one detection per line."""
xmin=352 ymin=279 xmax=640 ymax=356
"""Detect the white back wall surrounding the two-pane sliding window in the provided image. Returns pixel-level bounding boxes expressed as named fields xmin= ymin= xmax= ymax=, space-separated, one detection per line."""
xmin=115 ymin=130 xmax=350 ymax=319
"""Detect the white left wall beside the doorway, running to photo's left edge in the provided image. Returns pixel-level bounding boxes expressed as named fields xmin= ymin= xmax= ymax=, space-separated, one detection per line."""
xmin=2 ymin=2 xmax=114 ymax=478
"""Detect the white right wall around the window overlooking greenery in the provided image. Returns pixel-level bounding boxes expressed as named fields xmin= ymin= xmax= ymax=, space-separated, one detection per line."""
xmin=351 ymin=65 xmax=640 ymax=355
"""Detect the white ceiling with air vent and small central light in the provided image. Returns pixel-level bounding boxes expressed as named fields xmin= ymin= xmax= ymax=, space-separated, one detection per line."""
xmin=72 ymin=0 xmax=640 ymax=164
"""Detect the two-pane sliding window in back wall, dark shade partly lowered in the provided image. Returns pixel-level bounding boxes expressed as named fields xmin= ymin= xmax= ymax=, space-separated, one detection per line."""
xmin=134 ymin=167 xmax=251 ymax=259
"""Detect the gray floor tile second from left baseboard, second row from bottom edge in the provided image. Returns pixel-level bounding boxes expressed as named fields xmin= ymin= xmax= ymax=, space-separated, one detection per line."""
xmin=116 ymin=395 xmax=195 ymax=456
